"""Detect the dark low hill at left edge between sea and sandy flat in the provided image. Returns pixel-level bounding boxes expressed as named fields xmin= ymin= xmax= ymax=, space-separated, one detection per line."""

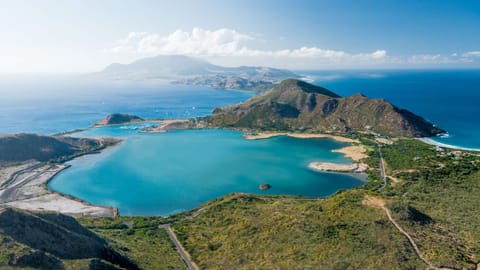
xmin=0 ymin=133 xmax=118 ymax=163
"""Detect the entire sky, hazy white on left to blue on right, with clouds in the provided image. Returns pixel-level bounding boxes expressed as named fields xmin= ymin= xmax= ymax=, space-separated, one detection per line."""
xmin=0 ymin=0 xmax=480 ymax=73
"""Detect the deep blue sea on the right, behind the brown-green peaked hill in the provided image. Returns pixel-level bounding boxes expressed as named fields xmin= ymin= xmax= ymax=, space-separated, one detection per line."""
xmin=302 ymin=70 xmax=480 ymax=149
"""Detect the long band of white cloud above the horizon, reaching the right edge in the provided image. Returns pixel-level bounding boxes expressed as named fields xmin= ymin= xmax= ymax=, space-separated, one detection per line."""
xmin=104 ymin=27 xmax=480 ymax=69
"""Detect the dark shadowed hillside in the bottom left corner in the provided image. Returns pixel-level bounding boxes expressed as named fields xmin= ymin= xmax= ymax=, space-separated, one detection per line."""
xmin=0 ymin=208 xmax=138 ymax=269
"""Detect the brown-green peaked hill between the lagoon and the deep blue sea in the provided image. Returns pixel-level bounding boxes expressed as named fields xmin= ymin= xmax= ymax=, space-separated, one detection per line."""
xmin=205 ymin=79 xmax=443 ymax=137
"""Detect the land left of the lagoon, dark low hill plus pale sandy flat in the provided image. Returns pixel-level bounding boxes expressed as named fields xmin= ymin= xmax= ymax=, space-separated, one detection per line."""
xmin=0 ymin=134 xmax=120 ymax=217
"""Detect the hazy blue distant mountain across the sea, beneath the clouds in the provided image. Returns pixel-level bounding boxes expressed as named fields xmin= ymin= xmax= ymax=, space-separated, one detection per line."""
xmin=91 ymin=55 xmax=300 ymax=90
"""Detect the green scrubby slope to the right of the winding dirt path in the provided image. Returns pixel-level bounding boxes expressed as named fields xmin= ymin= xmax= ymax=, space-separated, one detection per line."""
xmin=382 ymin=140 xmax=480 ymax=269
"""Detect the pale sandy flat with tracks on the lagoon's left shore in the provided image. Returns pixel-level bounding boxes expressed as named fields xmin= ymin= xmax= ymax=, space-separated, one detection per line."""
xmin=0 ymin=162 xmax=117 ymax=217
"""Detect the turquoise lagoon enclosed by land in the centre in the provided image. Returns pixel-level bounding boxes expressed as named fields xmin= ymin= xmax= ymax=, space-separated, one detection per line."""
xmin=49 ymin=125 xmax=363 ymax=215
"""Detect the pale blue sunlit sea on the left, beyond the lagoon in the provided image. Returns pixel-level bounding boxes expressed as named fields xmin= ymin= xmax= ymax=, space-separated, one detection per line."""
xmin=0 ymin=77 xmax=253 ymax=134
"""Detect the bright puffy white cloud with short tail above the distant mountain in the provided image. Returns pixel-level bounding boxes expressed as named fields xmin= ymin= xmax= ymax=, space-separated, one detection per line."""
xmin=104 ymin=28 xmax=387 ymax=64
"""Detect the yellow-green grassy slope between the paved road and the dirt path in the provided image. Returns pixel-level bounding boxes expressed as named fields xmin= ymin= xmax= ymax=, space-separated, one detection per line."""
xmin=174 ymin=190 xmax=424 ymax=269
